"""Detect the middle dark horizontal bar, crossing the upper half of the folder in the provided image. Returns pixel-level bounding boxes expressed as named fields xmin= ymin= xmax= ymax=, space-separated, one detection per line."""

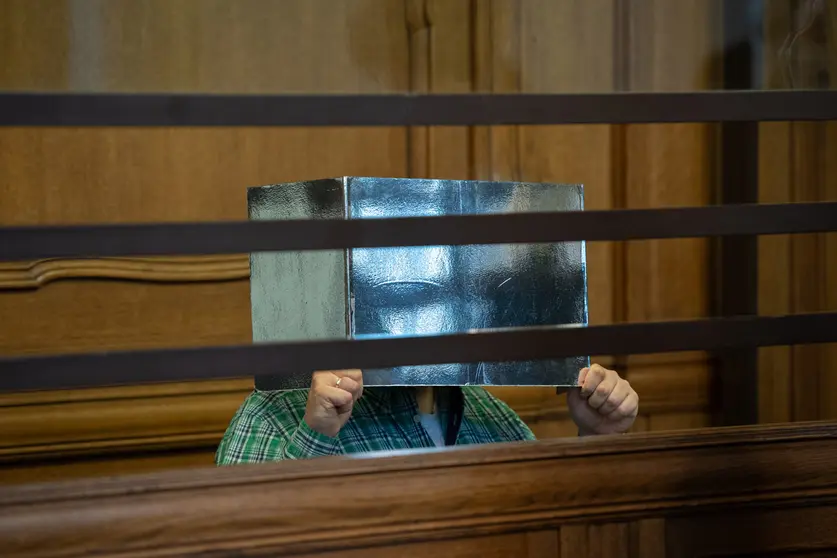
xmin=0 ymin=202 xmax=837 ymax=261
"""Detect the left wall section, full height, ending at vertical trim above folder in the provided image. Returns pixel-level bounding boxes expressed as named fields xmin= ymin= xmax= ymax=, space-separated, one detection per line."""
xmin=0 ymin=0 xmax=414 ymax=482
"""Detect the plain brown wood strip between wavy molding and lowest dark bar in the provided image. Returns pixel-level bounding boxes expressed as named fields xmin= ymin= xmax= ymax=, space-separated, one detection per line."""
xmin=0 ymin=280 xmax=251 ymax=354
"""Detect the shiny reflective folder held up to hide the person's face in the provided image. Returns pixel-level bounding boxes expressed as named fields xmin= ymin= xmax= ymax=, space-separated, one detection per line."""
xmin=248 ymin=177 xmax=588 ymax=389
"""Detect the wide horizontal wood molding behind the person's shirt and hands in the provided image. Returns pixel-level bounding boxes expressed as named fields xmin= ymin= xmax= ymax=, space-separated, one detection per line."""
xmin=0 ymin=367 xmax=710 ymax=464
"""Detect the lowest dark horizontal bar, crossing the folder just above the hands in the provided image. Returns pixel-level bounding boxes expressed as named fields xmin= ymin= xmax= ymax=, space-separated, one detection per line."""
xmin=0 ymin=312 xmax=837 ymax=391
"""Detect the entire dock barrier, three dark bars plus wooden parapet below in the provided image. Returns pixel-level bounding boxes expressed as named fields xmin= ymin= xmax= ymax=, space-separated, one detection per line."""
xmin=0 ymin=87 xmax=837 ymax=557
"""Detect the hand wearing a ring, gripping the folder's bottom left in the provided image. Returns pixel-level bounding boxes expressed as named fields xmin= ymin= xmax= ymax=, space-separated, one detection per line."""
xmin=304 ymin=370 xmax=363 ymax=438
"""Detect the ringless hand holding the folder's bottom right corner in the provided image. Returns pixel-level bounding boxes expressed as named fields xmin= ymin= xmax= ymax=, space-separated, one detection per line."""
xmin=567 ymin=364 xmax=639 ymax=436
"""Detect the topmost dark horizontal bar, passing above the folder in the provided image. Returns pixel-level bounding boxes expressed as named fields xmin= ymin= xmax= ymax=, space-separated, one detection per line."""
xmin=0 ymin=90 xmax=837 ymax=126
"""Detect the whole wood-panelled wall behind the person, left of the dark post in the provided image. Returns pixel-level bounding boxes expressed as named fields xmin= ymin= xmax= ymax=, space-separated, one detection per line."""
xmin=0 ymin=0 xmax=715 ymax=479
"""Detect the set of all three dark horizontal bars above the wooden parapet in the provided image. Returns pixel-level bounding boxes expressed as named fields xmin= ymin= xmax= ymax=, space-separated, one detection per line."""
xmin=0 ymin=91 xmax=837 ymax=391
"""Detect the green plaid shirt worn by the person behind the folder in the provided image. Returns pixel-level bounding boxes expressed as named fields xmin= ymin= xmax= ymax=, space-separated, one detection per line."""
xmin=215 ymin=386 xmax=535 ymax=465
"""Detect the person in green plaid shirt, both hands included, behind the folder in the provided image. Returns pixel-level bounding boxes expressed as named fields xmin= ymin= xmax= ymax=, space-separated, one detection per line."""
xmin=216 ymin=364 xmax=639 ymax=465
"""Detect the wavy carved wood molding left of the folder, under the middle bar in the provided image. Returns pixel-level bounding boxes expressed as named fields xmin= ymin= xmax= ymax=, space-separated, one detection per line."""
xmin=0 ymin=254 xmax=250 ymax=291
